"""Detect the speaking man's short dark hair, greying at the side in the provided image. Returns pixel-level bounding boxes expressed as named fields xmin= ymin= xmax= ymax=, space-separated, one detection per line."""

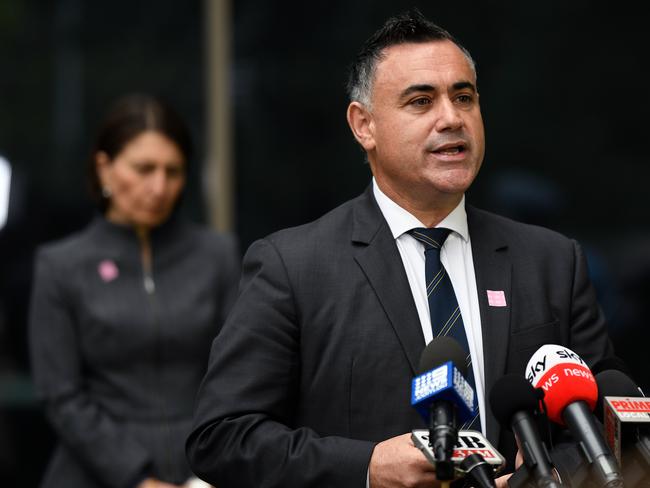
xmin=347 ymin=9 xmax=474 ymax=107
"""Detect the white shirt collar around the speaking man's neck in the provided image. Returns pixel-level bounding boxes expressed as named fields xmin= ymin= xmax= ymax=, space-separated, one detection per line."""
xmin=372 ymin=177 xmax=469 ymax=241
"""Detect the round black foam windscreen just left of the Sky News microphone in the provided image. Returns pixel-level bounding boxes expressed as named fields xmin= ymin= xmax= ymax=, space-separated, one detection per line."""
xmin=490 ymin=374 xmax=539 ymax=429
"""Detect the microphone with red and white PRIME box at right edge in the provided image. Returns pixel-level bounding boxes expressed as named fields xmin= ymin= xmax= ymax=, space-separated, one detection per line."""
xmin=595 ymin=369 xmax=650 ymax=487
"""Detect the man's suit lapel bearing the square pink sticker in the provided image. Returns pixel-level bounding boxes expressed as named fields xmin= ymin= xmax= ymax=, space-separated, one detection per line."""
xmin=467 ymin=206 xmax=512 ymax=444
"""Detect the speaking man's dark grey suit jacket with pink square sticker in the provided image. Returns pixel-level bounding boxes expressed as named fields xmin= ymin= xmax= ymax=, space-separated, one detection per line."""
xmin=187 ymin=188 xmax=612 ymax=488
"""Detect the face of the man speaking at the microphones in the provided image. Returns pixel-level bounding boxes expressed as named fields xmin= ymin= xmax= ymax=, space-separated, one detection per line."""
xmin=364 ymin=40 xmax=485 ymax=205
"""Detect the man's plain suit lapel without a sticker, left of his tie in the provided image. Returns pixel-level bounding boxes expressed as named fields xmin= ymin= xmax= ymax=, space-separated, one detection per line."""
xmin=352 ymin=186 xmax=424 ymax=374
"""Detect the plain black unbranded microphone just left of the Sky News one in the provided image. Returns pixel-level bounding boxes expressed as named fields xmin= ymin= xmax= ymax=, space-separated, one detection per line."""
xmin=490 ymin=375 xmax=561 ymax=488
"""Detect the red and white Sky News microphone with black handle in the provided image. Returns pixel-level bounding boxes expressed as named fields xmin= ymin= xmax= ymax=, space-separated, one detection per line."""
xmin=526 ymin=344 xmax=623 ymax=488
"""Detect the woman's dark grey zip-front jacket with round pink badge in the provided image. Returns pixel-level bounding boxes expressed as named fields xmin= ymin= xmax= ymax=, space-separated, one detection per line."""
xmin=30 ymin=217 xmax=240 ymax=488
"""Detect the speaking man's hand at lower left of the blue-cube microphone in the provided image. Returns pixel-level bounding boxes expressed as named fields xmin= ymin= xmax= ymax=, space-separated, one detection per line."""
xmin=368 ymin=434 xmax=438 ymax=488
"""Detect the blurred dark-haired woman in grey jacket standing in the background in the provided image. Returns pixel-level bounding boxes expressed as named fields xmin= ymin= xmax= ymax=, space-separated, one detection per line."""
xmin=30 ymin=95 xmax=240 ymax=488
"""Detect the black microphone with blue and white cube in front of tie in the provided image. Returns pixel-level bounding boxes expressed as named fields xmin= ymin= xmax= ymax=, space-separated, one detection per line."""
xmin=411 ymin=337 xmax=476 ymax=481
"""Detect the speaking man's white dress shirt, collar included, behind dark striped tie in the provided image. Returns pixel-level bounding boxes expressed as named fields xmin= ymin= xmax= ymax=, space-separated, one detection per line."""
xmin=372 ymin=178 xmax=485 ymax=434
